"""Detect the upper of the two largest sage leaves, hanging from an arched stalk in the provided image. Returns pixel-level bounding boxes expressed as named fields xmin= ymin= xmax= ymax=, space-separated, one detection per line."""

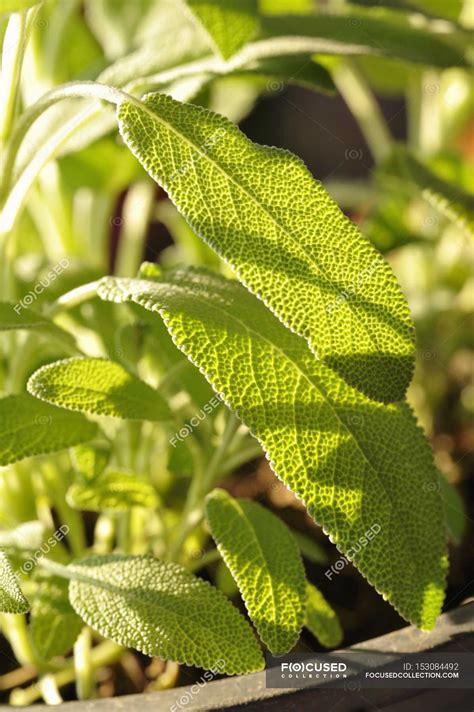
xmin=118 ymin=94 xmax=414 ymax=401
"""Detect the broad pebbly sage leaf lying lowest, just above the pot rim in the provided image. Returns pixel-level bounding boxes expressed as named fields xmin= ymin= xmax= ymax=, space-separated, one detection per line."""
xmin=68 ymin=554 xmax=264 ymax=675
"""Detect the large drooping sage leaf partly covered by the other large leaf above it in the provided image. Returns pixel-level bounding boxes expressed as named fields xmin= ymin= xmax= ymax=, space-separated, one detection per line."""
xmin=99 ymin=270 xmax=446 ymax=628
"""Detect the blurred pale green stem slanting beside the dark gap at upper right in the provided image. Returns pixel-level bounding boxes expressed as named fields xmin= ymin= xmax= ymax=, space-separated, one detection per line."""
xmin=334 ymin=60 xmax=393 ymax=163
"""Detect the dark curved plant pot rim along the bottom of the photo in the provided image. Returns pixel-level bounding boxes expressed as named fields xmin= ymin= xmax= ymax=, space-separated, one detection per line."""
xmin=0 ymin=602 xmax=474 ymax=712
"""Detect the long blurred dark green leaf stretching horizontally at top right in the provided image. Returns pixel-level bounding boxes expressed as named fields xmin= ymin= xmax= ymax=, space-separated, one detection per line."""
xmin=262 ymin=9 xmax=467 ymax=67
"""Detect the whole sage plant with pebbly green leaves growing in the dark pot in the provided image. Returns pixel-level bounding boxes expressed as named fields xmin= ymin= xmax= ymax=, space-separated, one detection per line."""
xmin=0 ymin=0 xmax=473 ymax=704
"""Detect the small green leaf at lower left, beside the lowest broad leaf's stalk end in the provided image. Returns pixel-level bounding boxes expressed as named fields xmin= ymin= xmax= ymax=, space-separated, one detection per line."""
xmin=29 ymin=576 xmax=84 ymax=661
